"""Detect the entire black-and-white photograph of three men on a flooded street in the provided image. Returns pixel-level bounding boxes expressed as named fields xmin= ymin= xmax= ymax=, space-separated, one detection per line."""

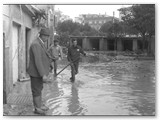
xmin=2 ymin=3 xmax=157 ymax=117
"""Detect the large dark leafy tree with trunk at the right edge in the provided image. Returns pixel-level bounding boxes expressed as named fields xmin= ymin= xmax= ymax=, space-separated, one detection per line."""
xmin=119 ymin=4 xmax=155 ymax=50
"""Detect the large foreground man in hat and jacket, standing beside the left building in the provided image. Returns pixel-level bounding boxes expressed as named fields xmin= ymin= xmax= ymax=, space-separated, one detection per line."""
xmin=27 ymin=28 xmax=55 ymax=115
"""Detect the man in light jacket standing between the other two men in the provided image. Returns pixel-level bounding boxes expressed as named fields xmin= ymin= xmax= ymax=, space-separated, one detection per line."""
xmin=48 ymin=38 xmax=63 ymax=77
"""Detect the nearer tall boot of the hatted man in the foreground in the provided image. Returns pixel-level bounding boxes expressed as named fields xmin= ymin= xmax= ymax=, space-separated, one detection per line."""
xmin=33 ymin=96 xmax=45 ymax=115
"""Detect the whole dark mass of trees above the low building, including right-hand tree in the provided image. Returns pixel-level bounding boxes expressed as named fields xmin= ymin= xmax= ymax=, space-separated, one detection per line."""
xmin=56 ymin=4 xmax=155 ymax=52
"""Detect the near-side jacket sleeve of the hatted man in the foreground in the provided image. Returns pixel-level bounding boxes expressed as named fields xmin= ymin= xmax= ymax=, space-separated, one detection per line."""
xmin=32 ymin=45 xmax=45 ymax=77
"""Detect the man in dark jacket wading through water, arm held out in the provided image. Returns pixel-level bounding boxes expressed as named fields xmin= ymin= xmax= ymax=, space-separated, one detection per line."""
xmin=67 ymin=39 xmax=86 ymax=82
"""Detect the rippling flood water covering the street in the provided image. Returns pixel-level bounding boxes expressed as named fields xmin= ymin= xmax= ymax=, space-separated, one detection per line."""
xmin=43 ymin=56 xmax=155 ymax=115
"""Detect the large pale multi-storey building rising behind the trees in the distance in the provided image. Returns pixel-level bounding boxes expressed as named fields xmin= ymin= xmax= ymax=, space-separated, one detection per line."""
xmin=75 ymin=14 xmax=119 ymax=30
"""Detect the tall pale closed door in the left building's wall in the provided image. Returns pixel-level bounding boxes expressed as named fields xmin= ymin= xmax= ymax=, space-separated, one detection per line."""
xmin=12 ymin=25 xmax=18 ymax=84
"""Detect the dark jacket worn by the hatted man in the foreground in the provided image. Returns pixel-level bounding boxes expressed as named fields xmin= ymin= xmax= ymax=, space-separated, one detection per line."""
xmin=27 ymin=38 xmax=51 ymax=77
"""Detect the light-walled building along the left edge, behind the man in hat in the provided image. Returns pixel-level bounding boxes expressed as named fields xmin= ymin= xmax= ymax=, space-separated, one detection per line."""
xmin=3 ymin=5 xmax=47 ymax=102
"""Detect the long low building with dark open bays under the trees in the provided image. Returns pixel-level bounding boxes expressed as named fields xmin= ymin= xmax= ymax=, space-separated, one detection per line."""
xmin=70 ymin=36 xmax=155 ymax=55
